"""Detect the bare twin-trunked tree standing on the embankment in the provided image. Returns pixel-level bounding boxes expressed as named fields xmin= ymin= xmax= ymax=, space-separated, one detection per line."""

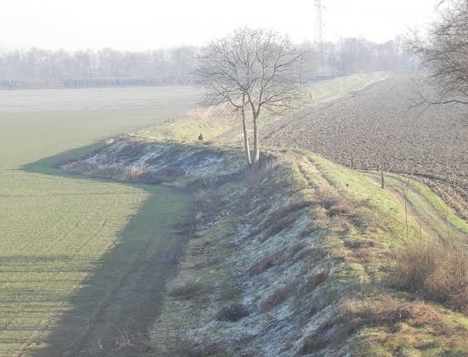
xmin=195 ymin=28 xmax=305 ymax=166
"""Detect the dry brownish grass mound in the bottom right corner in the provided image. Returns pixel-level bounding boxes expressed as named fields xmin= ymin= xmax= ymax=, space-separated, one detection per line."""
xmin=346 ymin=295 xmax=468 ymax=357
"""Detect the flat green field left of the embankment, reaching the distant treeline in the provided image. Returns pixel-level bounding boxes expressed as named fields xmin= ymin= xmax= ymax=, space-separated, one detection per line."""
xmin=0 ymin=87 xmax=196 ymax=356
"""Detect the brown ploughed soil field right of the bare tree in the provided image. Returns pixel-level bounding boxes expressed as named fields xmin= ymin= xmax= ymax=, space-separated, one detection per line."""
xmin=263 ymin=77 xmax=468 ymax=218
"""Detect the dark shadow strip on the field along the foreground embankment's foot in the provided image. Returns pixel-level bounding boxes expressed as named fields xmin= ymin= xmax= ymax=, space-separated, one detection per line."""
xmin=40 ymin=195 xmax=186 ymax=356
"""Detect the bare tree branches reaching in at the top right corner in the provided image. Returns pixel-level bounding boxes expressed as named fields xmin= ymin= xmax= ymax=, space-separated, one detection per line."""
xmin=408 ymin=0 xmax=468 ymax=104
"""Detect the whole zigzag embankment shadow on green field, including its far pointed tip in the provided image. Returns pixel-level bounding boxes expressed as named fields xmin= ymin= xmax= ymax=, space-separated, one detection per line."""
xmin=16 ymin=145 xmax=187 ymax=357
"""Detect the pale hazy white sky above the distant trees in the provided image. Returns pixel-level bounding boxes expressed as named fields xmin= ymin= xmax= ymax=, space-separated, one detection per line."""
xmin=0 ymin=0 xmax=437 ymax=51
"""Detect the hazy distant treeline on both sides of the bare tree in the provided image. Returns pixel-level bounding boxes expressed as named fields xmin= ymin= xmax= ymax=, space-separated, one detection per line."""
xmin=0 ymin=38 xmax=411 ymax=89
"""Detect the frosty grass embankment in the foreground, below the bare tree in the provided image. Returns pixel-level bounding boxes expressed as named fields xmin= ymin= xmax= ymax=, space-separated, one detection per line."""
xmin=154 ymin=146 xmax=468 ymax=356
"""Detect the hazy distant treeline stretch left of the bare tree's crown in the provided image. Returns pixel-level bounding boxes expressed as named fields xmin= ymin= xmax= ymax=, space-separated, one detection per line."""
xmin=0 ymin=47 xmax=197 ymax=88
